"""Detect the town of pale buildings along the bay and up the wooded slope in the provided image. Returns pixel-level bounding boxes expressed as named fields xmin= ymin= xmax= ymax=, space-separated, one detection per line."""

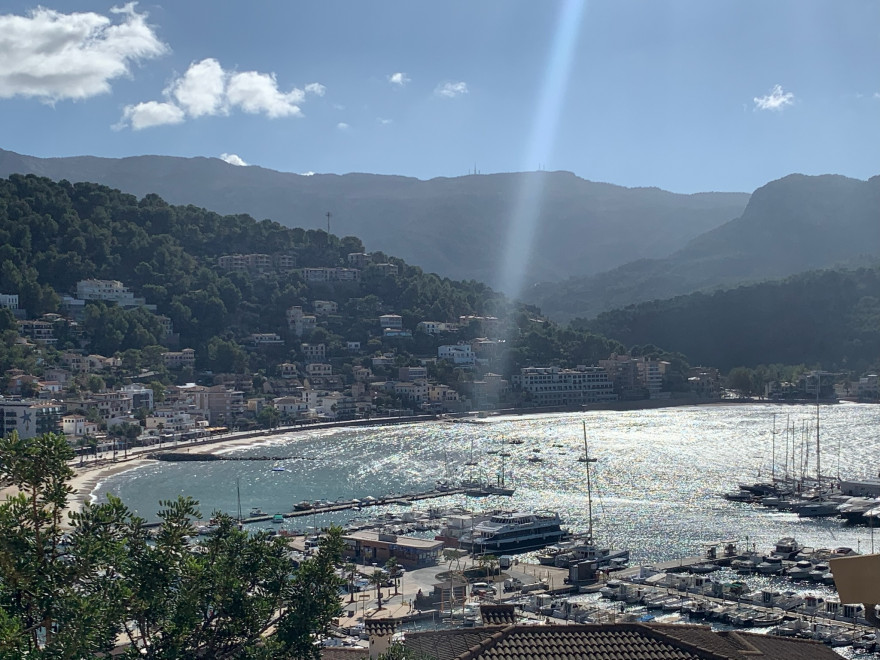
xmin=0 ymin=268 xmax=878 ymax=453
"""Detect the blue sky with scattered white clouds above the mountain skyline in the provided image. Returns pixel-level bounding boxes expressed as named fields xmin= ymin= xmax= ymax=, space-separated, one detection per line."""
xmin=0 ymin=0 xmax=880 ymax=192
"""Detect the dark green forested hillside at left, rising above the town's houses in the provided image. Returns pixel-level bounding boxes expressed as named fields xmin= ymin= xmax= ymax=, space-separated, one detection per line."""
xmin=0 ymin=175 xmax=621 ymax=382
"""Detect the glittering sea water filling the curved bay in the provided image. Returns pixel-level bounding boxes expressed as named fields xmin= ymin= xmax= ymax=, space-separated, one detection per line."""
xmin=92 ymin=403 xmax=880 ymax=564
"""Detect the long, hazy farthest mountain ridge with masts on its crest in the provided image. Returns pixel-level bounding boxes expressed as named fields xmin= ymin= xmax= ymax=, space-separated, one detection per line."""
xmin=0 ymin=150 xmax=749 ymax=296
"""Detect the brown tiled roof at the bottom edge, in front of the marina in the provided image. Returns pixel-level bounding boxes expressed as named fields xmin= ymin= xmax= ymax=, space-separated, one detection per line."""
xmin=405 ymin=623 xmax=839 ymax=660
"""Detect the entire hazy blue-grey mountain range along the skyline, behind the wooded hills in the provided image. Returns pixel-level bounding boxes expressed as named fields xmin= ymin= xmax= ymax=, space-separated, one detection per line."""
xmin=0 ymin=150 xmax=880 ymax=330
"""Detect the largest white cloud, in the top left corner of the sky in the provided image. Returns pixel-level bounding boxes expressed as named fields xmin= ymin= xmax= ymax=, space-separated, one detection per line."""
xmin=0 ymin=3 xmax=168 ymax=102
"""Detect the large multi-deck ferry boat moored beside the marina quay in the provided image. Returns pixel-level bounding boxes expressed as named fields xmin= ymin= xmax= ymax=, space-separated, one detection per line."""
xmin=459 ymin=511 xmax=568 ymax=556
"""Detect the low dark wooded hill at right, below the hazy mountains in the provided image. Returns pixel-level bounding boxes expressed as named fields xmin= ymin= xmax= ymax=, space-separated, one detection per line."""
xmin=573 ymin=266 xmax=880 ymax=373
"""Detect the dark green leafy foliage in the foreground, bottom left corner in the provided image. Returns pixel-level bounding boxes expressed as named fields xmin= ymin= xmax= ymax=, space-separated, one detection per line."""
xmin=0 ymin=433 xmax=342 ymax=660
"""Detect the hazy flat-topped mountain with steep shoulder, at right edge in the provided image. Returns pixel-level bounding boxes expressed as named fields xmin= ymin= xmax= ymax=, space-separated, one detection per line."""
xmin=522 ymin=174 xmax=880 ymax=321
